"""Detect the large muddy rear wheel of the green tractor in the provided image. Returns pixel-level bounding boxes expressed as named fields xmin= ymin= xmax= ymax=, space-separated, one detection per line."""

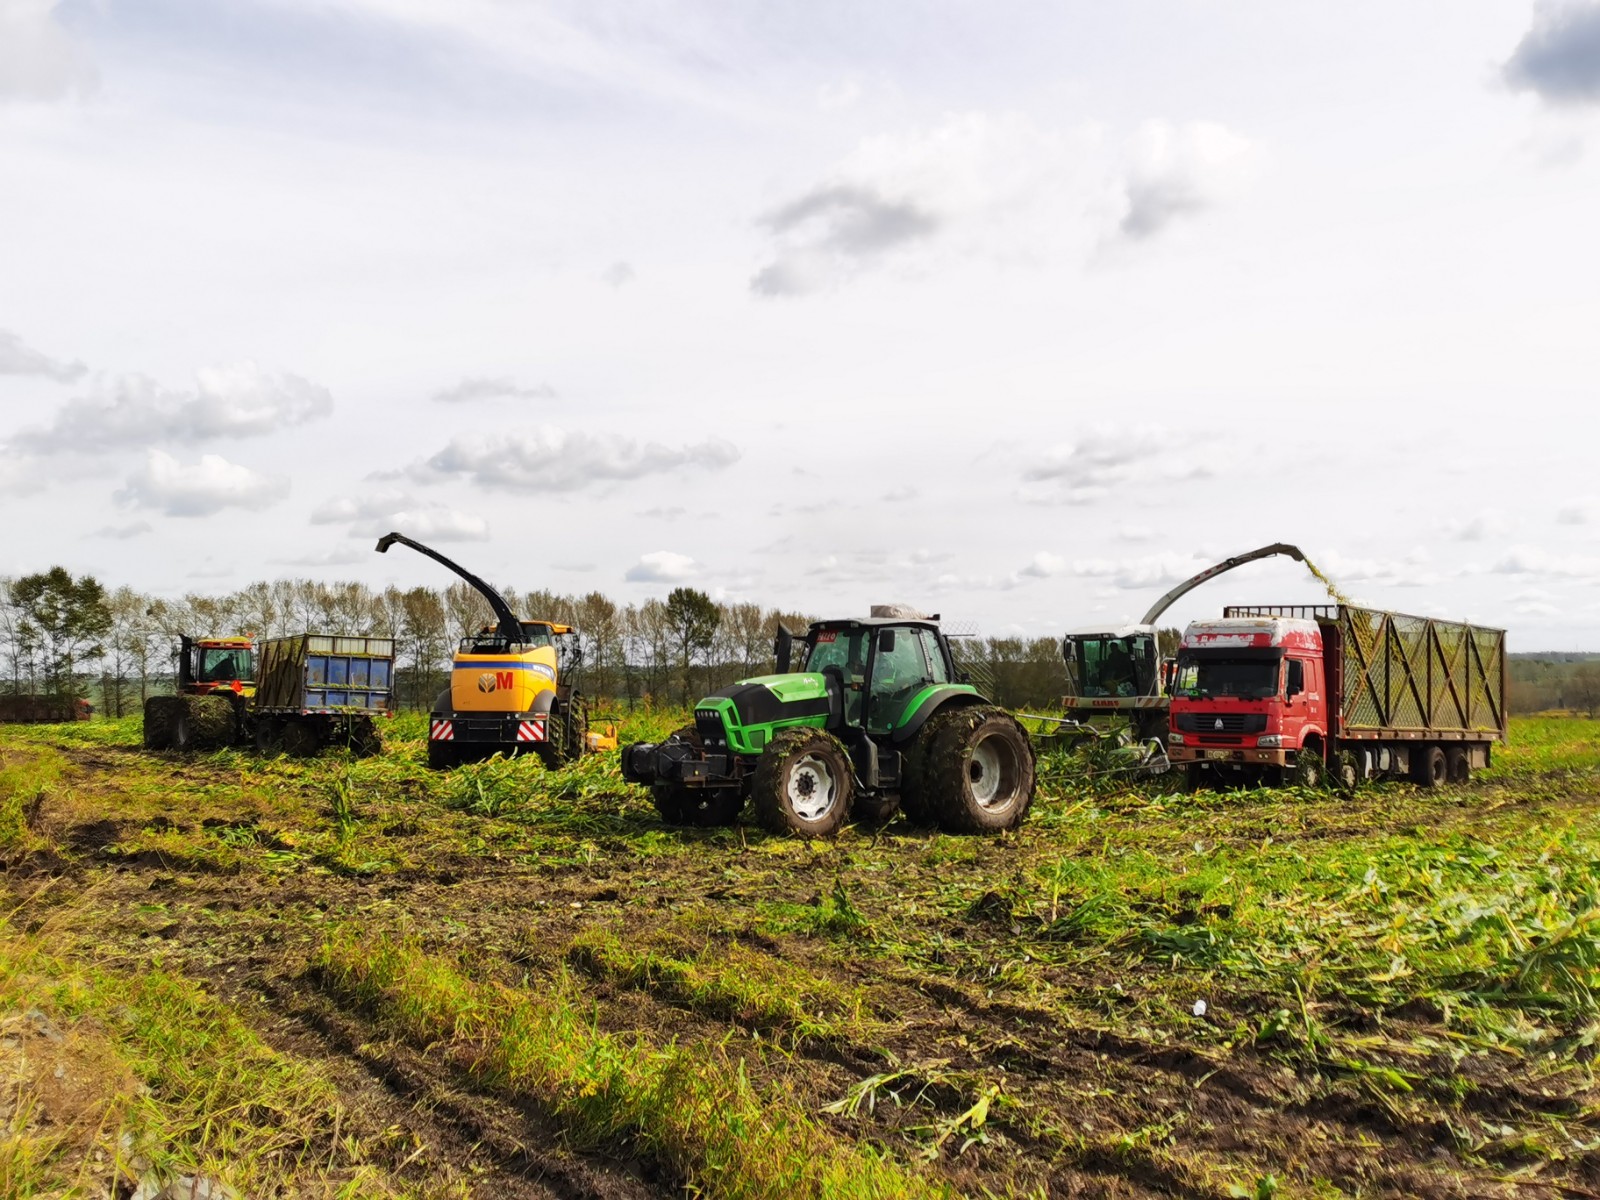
xmin=922 ymin=704 xmax=1034 ymax=834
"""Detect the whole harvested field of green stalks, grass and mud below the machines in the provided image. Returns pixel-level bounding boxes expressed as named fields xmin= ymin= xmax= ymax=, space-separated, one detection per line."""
xmin=0 ymin=712 xmax=1600 ymax=1198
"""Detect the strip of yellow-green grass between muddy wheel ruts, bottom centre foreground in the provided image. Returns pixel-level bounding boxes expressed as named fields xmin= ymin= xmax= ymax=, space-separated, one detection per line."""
xmin=317 ymin=928 xmax=947 ymax=1200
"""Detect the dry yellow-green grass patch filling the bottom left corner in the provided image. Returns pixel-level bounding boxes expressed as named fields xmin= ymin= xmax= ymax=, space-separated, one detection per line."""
xmin=0 ymin=922 xmax=406 ymax=1198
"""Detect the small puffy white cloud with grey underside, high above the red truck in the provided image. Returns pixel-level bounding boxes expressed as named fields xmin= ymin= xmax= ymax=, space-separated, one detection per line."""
xmin=1117 ymin=122 xmax=1251 ymax=242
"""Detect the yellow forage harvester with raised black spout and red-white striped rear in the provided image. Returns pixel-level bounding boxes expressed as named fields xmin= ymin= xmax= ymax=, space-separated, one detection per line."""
xmin=378 ymin=533 xmax=616 ymax=766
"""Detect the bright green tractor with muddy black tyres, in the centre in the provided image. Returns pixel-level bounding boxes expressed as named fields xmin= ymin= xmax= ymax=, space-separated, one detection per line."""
xmin=622 ymin=616 xmax=1034 ymax=837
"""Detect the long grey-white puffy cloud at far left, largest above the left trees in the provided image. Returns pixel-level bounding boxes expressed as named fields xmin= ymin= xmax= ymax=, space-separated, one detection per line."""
xmin=13 ymin=362 xmax=333 ymax=453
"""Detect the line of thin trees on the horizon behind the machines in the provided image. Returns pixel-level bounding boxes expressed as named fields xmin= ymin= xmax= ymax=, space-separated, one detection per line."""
xmin=0 ymin=566 xmax=1066 ymax=715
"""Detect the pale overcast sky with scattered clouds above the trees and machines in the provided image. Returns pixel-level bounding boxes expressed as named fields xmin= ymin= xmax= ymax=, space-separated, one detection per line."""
xmin=0 ymin=0 xmax=1600 ymax=651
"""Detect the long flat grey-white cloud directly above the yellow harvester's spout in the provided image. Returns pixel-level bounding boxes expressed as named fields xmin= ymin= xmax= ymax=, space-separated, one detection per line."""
xmin=411 ymin=427 xmax=739 ymax=493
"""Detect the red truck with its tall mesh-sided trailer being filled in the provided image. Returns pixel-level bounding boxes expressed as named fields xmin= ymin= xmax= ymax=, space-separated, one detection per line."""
xmin=1166 ymin=605 xmax=1506 ymax=787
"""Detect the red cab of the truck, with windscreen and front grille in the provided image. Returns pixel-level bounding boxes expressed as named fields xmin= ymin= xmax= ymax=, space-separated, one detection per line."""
xmin=1166 ymin=616 xmax=1331 ymax=786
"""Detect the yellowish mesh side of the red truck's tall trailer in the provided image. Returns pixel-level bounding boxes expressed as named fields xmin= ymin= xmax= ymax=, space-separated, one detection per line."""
xmin=1224 ymin=605 xmax=1506 ymax=741
